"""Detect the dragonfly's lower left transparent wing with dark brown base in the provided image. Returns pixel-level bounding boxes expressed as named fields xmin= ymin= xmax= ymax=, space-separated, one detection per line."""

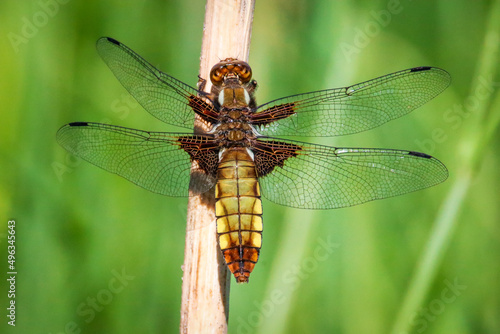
xmin=57 ymin=122 xmax=217 ymax=196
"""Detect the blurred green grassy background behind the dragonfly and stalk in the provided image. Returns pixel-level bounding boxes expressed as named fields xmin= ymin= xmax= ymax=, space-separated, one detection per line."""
xmin=0 ymin=0 xmax=500 ymax=334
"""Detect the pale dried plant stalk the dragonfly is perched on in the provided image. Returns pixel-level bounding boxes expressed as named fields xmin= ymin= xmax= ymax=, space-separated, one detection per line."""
xmin=180 ymin=0 xmax=255 ymax=333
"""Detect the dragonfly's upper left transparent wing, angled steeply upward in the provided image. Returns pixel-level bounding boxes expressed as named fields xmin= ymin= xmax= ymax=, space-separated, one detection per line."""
xmin=97 ymin=37 xmax=215 ymax=129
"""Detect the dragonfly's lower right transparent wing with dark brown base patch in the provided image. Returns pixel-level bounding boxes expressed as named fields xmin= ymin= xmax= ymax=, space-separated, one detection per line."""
xmin=253 ymin=139 xmax=448 ymax=209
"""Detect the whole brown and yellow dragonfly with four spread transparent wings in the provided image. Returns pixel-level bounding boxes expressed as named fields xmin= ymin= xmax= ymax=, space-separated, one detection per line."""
xmin=57 ymin=37 xmax=450 ymax=283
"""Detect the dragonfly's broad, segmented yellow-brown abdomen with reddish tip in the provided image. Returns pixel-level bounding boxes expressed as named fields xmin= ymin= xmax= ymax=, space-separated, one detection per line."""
xmin=215 ymin=147 xmax=262 ymax=283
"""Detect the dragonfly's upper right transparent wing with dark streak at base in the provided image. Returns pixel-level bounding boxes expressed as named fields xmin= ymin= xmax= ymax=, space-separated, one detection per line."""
xmin=253 ymin=67 xmax=451 ymax=136
